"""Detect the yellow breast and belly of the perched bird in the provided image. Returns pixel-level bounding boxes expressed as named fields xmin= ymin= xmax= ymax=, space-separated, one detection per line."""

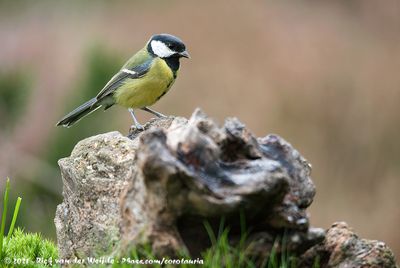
xmin=114 ymin=58 xmax=175 ymax=108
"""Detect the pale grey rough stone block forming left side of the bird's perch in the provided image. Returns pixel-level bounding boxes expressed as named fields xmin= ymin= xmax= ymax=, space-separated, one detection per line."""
xmin=55 ymin=132 xmax=136 ymax=258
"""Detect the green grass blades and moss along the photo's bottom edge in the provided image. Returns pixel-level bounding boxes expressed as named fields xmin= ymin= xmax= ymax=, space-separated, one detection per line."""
xmin=0 ymin=179 xmax=319 ymax=268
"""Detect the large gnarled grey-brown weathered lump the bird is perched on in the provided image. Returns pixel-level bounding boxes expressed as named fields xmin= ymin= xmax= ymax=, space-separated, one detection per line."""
xmin=55 ymin=110 xmax=396 ymax=266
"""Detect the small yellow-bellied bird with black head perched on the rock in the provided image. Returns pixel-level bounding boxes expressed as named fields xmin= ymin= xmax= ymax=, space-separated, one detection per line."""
xmin=57 ymin=33 xmax=190 ymax=130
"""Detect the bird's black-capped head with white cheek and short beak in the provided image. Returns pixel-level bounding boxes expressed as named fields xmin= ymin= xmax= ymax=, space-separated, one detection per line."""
xmin=147 ymin=34 xmax=189 ymax=58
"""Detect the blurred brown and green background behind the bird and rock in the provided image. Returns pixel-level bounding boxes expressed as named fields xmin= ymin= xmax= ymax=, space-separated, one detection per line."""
xmin=0 ymin=0 xmax=400 ymax=257
